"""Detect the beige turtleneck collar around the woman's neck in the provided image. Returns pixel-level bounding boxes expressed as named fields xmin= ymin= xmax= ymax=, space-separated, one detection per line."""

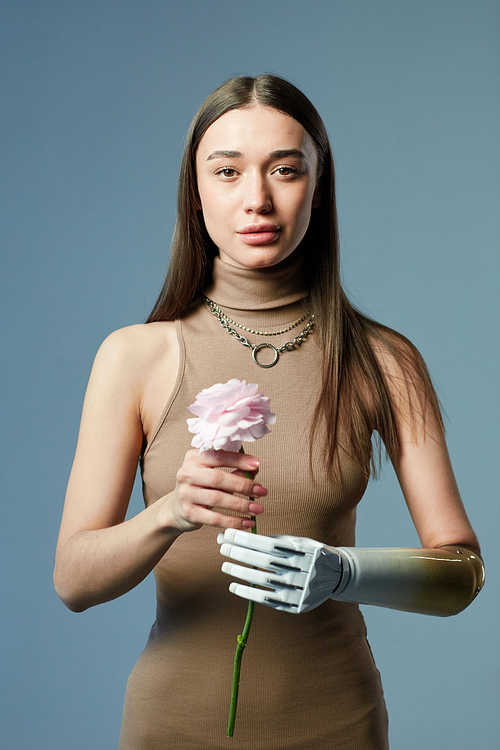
xmin=205 ymin=253 xmax=307 ymax=310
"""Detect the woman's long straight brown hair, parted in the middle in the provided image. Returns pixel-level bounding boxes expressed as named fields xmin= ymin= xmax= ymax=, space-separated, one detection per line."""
xmin=147 ymin=75 xmax=440 ymax=474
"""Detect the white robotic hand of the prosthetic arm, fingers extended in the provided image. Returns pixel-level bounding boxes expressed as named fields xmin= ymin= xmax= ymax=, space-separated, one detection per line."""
xmin=217 ymin=529 xmax=343 ymax=614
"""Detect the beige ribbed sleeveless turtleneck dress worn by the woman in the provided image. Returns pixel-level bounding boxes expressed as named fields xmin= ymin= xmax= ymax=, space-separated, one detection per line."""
xmin=120 ymin=256 xmax=388 ymax=750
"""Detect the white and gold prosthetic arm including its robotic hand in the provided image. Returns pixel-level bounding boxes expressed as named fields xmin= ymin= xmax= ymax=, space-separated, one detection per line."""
xmin=217 ymin=529 xmax=484 ymax=617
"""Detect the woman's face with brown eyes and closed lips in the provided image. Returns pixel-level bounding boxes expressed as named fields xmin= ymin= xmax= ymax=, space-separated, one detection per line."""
xmin=196 ymin=104 xmax=319 ymax=268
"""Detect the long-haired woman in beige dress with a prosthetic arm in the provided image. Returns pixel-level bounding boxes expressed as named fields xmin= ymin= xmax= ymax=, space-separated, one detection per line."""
xmin=55 ymin=75 xmax=482 ymax=750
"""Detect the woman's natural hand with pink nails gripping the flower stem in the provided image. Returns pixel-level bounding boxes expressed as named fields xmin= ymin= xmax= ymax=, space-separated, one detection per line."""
xmin=161 ymin=450 xmax=267 ymax=534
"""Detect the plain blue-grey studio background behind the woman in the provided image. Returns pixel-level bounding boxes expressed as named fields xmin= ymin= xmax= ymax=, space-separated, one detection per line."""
xmin=0 ymin=0 xmax=500 ymax=750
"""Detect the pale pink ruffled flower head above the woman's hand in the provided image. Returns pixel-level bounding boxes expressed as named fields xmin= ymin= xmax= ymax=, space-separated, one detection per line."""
xmin=187 ymin=378 xmax=276 ymax=453
